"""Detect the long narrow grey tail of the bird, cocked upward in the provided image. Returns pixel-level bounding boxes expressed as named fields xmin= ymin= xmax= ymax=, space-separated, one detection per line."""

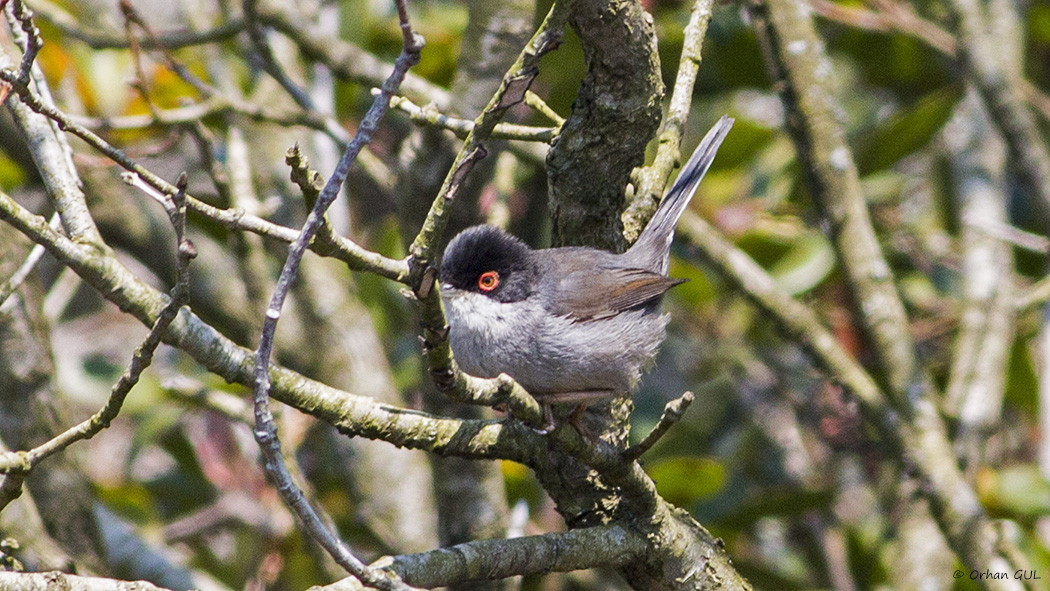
xmin=626 ymin=115 xmax=733 ymax=275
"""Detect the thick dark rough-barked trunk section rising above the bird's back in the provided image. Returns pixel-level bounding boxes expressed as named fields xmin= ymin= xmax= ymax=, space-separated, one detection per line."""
xmin=547 ymin=0 xmax=664 ymax=252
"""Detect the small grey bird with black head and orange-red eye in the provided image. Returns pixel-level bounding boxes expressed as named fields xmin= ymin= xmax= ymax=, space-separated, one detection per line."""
xmin=440 ymin=117 xmax=733 ymax=424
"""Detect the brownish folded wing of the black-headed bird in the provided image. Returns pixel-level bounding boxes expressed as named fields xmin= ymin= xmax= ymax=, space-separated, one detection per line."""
xmin=547 ymin=266 xmax=685 ymax=321
